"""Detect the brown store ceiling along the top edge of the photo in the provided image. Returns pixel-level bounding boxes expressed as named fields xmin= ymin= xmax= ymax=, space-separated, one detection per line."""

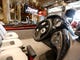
xmin=26 ymin=0 xmax=78 ymax=9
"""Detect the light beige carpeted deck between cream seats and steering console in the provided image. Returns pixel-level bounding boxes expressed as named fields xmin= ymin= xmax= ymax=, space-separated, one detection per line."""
xmin=22 ymin=39 xmax=50 ymax=60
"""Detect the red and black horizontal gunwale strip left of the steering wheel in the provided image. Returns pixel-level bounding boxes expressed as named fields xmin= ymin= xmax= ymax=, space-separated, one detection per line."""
xmin=4 ymin=24 xmax=36 ymax=30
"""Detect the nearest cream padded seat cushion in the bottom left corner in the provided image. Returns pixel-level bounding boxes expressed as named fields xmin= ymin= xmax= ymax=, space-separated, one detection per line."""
xmin=0 ymin=48 xmax=28 ymax=60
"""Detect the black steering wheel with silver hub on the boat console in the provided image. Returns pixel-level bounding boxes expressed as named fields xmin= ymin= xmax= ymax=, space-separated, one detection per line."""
xmin=33 ymin=19 xmax=52 ymax=41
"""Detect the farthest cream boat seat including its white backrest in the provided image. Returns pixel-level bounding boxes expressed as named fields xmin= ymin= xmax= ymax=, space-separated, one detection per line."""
xmin=0 ymin=24 xmax=19 ymax=39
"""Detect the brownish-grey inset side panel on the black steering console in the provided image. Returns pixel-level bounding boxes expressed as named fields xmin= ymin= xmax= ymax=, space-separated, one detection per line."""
xmin=51 ymin=31 xmax=63 ymax=59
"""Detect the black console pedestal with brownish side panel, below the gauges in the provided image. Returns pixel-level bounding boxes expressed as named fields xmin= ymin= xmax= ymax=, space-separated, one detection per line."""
xmin=51 ymin=30 xmax=70 ymax=60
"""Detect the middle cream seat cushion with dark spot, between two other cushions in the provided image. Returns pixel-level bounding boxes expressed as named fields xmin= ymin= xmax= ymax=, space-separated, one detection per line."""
xmin=0 ymin=39 xmax=23 ymax=50
